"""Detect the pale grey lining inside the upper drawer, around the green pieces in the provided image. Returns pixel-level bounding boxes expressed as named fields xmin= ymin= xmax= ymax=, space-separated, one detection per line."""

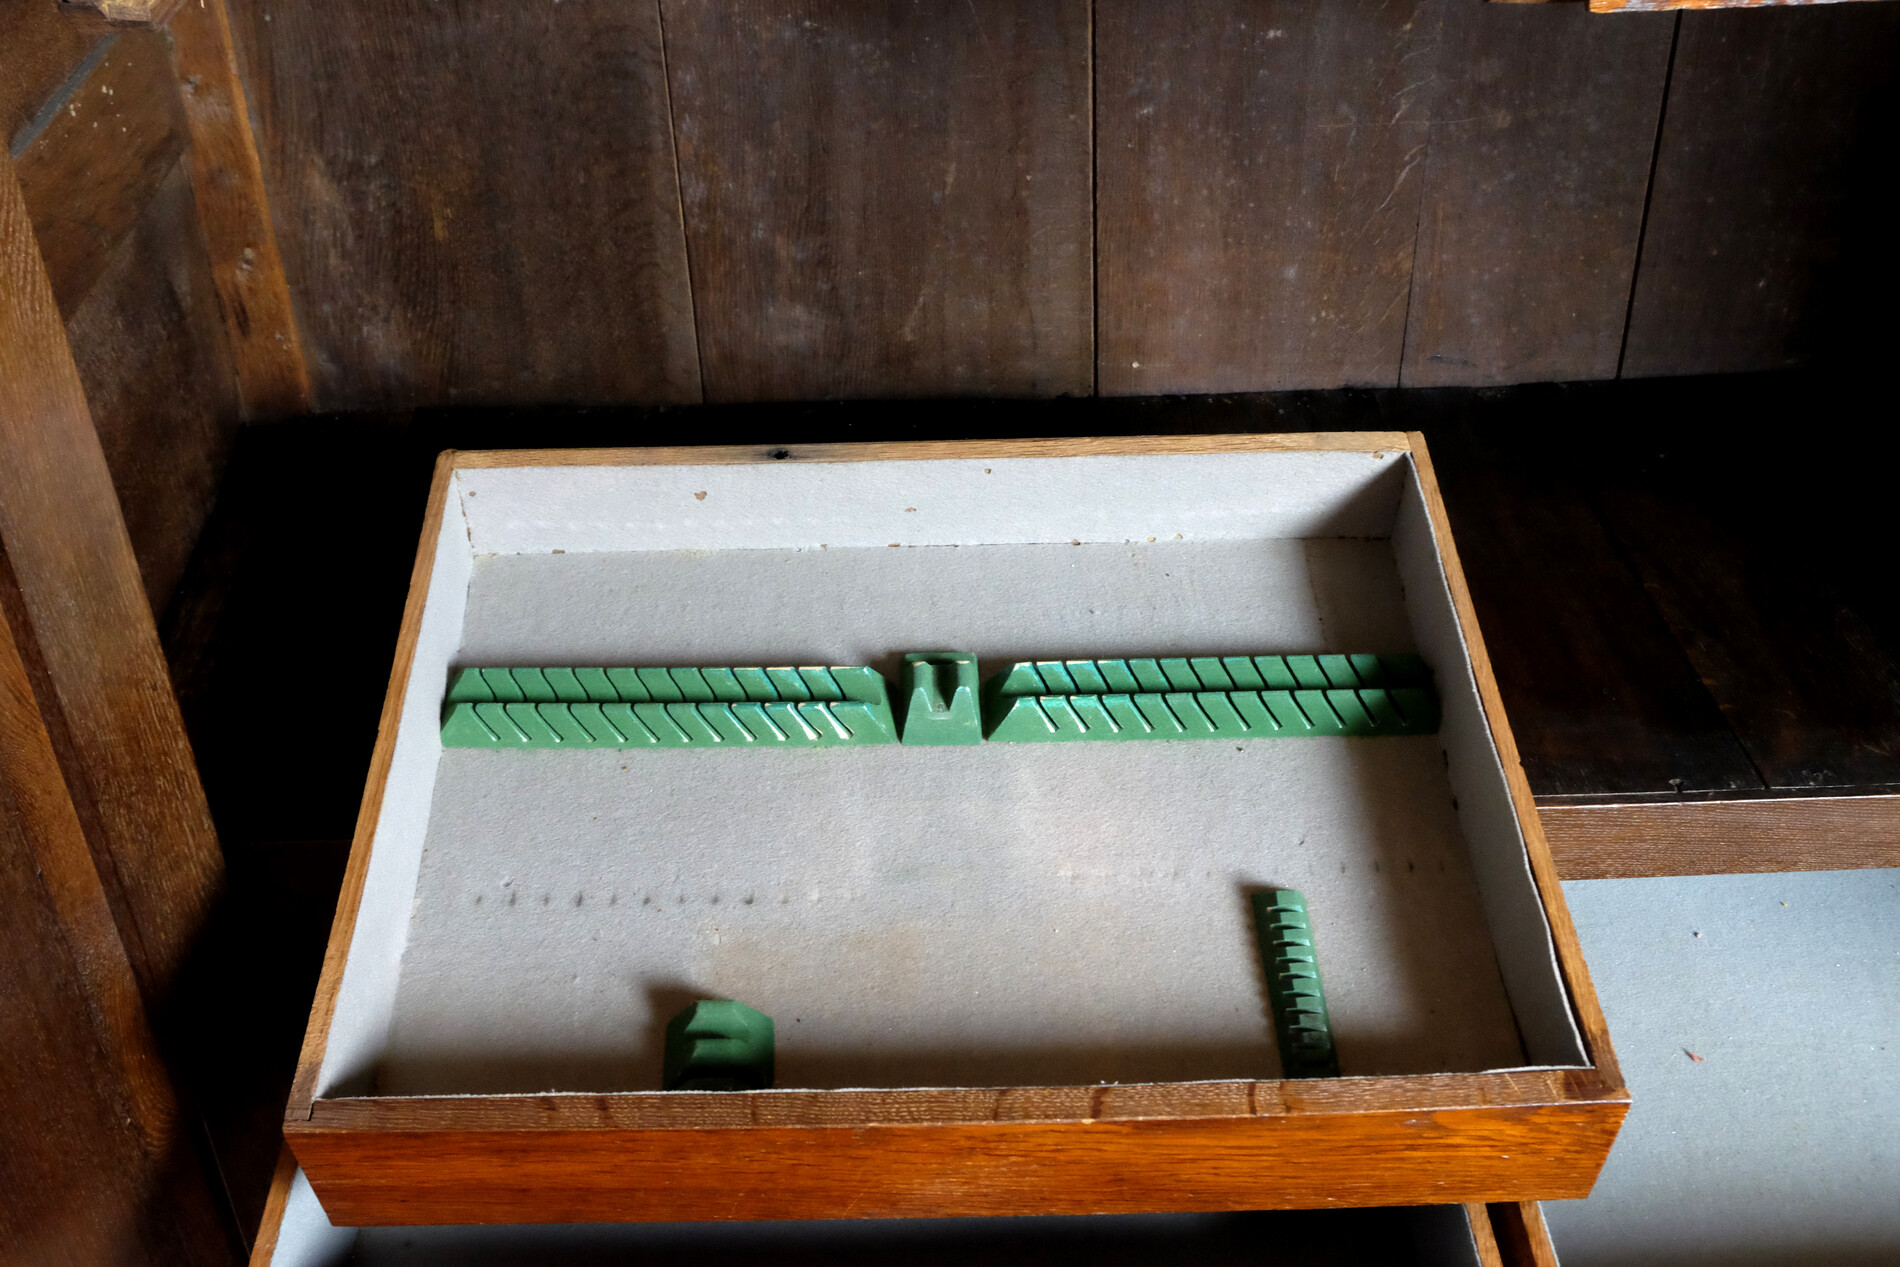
xmin=319 ymin=454 xmax=1581 ymax=1094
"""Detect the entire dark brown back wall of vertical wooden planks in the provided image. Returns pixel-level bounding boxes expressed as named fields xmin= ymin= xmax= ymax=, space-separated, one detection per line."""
xmin=215 ymin=0 xmax=1900 ymax=408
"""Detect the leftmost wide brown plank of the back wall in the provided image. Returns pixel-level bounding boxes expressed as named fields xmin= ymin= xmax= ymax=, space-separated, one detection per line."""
xmin=231 ymin=0 xmax=699 ymax=408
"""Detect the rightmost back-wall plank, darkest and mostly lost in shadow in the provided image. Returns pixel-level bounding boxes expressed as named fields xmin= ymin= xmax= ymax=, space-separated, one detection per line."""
xmin=1604 ymin=4 xmax=1900 ymax=376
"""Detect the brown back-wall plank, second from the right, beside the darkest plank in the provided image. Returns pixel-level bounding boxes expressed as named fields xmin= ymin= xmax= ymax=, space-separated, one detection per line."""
xmin=1402 ymin=0 xmax=1676 ymax=388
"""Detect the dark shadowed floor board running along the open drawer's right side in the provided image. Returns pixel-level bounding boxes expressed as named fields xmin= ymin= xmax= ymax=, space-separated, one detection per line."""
xmin=1408 ymin=398 xmax=1761 ymax=796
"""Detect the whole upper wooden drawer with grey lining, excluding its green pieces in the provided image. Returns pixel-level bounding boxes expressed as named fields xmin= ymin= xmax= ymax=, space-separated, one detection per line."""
xmin=287 ymin=433 xmax=1628 ymax=1225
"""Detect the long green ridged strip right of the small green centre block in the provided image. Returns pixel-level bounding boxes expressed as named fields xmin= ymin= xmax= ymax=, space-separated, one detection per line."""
xmin=982 ymin=655 xmax=1438 ymax=743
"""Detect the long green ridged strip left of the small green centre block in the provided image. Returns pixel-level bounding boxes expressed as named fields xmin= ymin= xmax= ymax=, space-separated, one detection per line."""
xmin=443 ymin=665 xmax=897 ymax=748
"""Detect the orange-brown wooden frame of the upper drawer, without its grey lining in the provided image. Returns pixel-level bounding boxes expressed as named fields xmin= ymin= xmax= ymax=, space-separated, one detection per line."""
xmin=285 ymin=433 xmax=1628 ymax=1225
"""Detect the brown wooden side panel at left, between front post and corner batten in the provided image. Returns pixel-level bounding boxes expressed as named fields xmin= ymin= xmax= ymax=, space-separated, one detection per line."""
xmin=0 ymin=16 xmax=241 ymax=612
